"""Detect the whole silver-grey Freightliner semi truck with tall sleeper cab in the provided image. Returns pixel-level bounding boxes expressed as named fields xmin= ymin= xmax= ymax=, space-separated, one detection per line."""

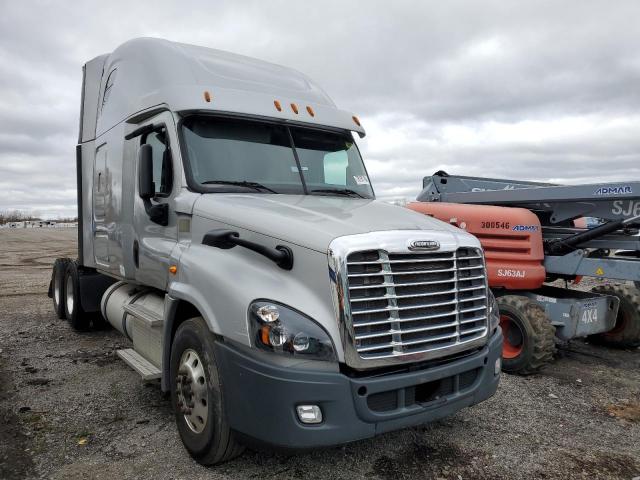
xmin=50 ymin=39 xmax=502 ymax=464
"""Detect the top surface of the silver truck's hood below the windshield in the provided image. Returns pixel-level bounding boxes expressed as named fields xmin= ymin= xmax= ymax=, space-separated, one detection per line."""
xmin=193 ymin=193 xmax=470 ymax=253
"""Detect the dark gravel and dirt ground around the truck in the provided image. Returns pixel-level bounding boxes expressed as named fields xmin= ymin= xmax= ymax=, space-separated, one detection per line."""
xmin=0 ymin=229 xmax=640 ymax=480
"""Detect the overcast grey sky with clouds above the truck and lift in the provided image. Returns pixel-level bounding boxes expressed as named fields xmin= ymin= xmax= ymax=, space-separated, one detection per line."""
xmin=0 ymin=0 xmax=640 ymax=216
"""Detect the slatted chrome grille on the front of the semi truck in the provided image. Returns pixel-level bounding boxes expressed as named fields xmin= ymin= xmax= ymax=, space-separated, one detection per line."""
xmin=347 ymin=248 xmax=487 ymax=359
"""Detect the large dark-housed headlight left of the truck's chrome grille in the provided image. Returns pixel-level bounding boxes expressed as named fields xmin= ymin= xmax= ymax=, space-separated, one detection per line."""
xmin=249 ymin=300 xmax=337 ymax=361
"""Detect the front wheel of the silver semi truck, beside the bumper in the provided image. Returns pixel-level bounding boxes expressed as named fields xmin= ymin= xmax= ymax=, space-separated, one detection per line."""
xmin=170 ymin=317 xmax=244 ymax=465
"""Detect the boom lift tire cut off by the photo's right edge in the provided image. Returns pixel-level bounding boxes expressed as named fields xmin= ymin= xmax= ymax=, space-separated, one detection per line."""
xmin=589 ymin=285 xmax=640 ymax=348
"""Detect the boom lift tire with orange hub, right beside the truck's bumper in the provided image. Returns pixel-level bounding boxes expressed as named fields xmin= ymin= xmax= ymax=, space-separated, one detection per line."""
xmin=497 ymin=295 xmax=556 ymax=375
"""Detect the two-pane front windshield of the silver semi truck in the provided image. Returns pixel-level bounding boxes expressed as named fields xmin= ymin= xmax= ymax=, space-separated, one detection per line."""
xmin=182 ymin=116 xmax=373 ymax=198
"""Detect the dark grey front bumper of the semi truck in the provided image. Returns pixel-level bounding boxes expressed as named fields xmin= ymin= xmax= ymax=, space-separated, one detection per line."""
xmin=216 ymin=329 xmax=502 ymax=448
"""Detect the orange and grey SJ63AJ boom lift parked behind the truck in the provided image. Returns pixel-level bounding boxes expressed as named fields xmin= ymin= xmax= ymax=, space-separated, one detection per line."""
xmin=407 ymin=172 xmax=640 ymax=374
